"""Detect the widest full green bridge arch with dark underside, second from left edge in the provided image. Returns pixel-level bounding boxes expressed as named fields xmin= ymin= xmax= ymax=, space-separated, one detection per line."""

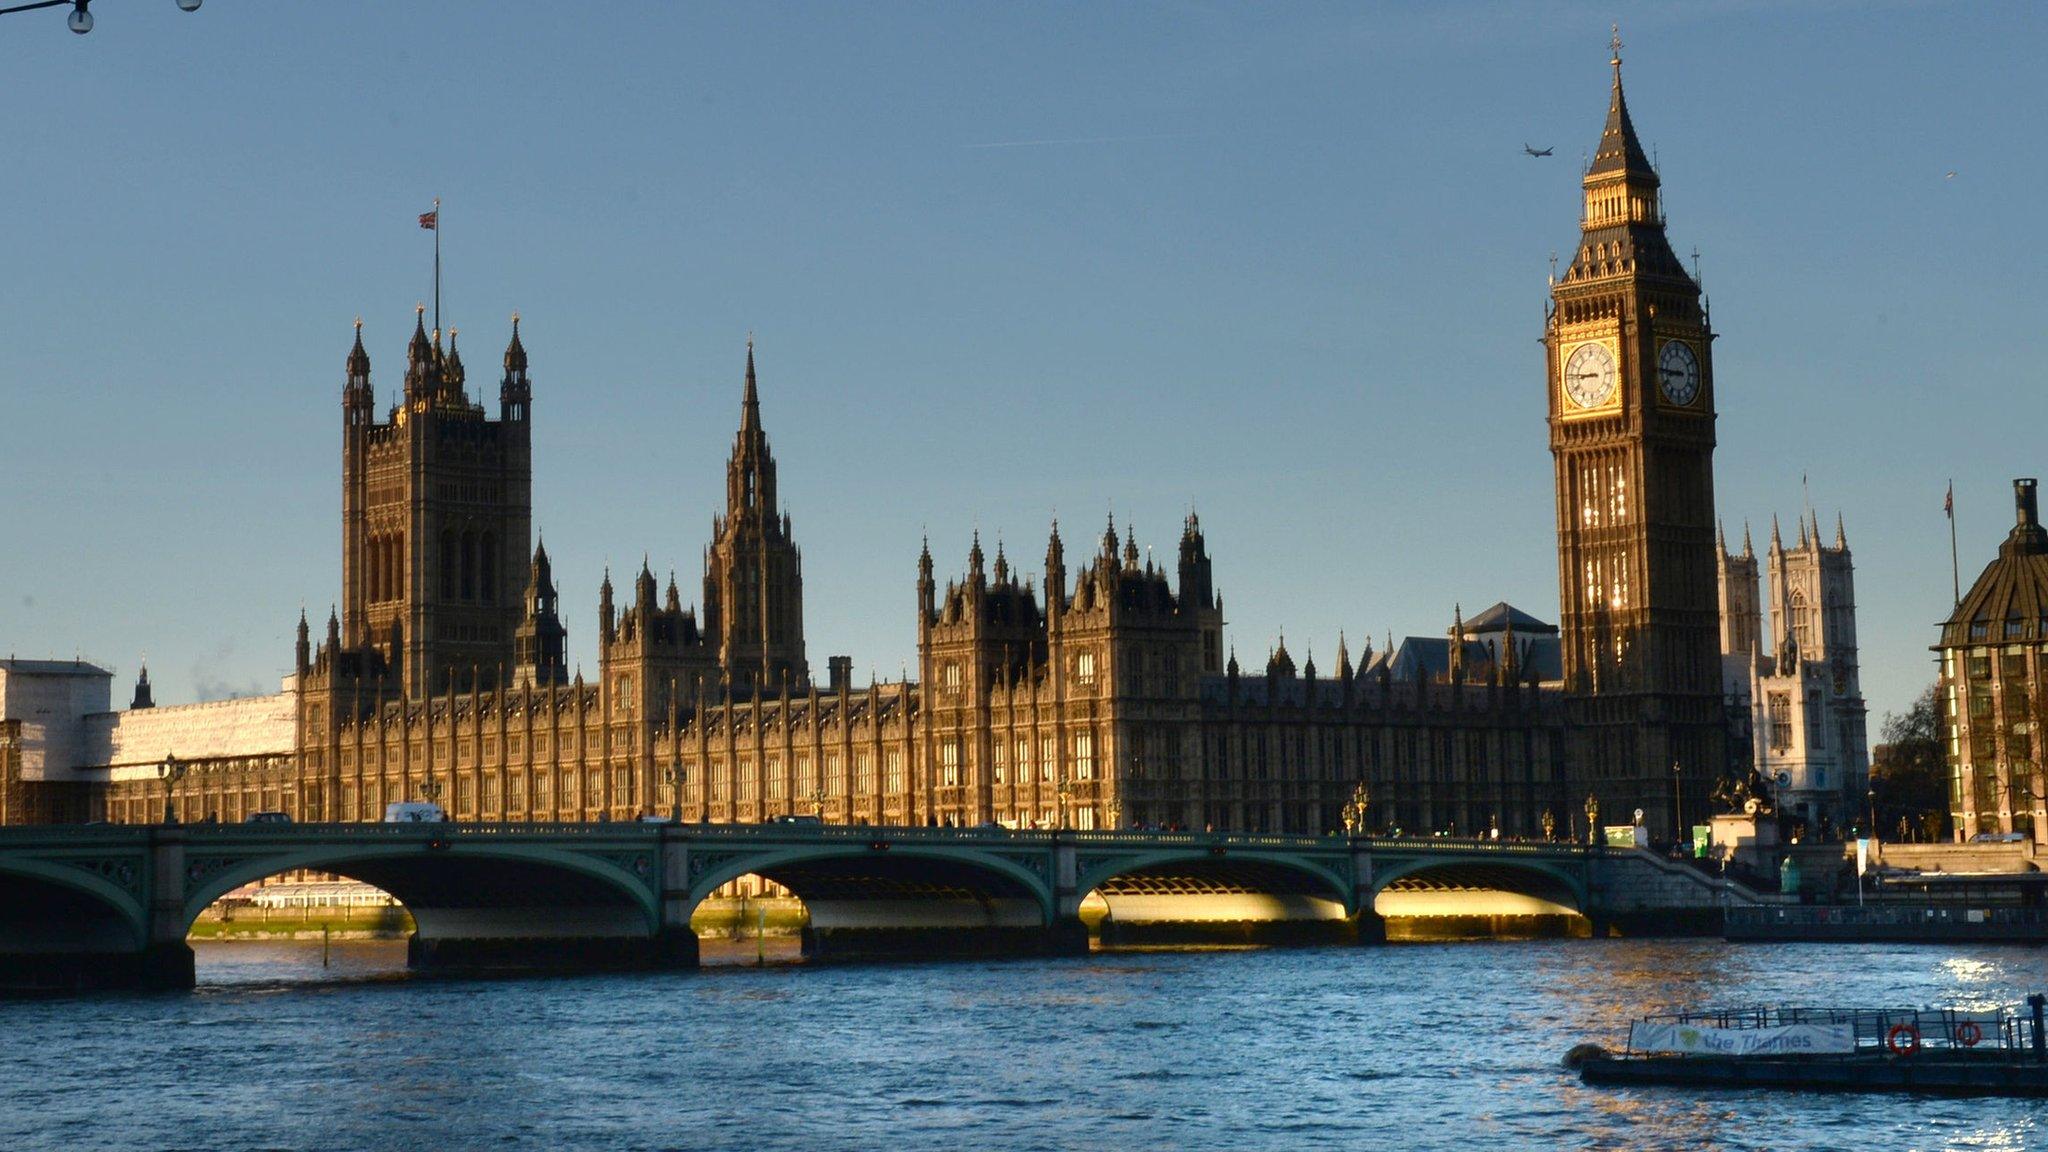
xmin=182 ymin=838 xmax=662 ymax=968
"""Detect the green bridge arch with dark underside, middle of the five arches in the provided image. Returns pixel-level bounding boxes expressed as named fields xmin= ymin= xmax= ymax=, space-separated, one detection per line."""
xmin=688 ymin=840 xmax=1059 ymax=959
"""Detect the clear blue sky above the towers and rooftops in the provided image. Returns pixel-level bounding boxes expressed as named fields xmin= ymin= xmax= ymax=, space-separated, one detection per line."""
xmin=0 ymin=0 xmax=2048 ymax=728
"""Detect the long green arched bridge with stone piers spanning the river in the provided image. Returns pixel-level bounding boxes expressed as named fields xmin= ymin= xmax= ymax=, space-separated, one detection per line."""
xmin=0 ymin=822 xmax=1757 ymax=988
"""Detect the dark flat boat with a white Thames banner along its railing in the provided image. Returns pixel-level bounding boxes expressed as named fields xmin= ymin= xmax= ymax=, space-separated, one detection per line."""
xmin=1565 ymin=996 xmax=2048 ymax=1097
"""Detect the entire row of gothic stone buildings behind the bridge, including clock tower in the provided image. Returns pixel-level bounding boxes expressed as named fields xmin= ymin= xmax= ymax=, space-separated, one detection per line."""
xmin=0 ymin=51 xmax=1866 ymax=838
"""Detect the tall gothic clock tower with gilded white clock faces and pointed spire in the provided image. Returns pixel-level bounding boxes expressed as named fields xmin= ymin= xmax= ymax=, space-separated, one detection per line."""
xmin=1544 ymin=37 xmax=1726 ymax=838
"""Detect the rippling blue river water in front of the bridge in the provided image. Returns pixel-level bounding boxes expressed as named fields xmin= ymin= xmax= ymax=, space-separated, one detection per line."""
xmin=0 ymin=941 xmax=2048 ymax=1152
